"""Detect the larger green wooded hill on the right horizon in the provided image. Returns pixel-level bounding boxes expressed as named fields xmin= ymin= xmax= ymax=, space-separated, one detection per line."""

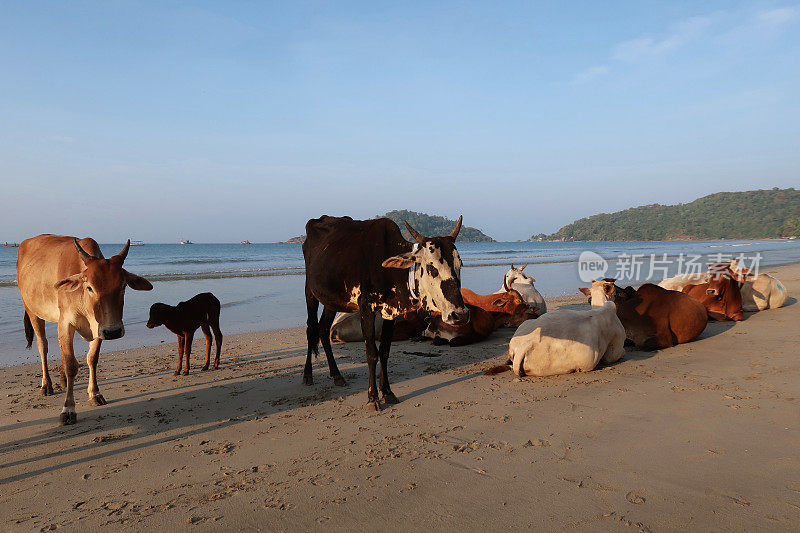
xmin=531 ymin=188 xmax=800 ymax=241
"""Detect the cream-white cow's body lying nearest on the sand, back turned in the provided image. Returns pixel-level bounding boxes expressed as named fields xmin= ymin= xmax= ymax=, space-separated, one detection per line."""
xmin=508 ymin=301 xmax=625 ymax=376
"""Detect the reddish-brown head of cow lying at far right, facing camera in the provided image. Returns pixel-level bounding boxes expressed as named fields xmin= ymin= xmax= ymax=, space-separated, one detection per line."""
xmin=683 ymin=263 xmax=746 ymax=322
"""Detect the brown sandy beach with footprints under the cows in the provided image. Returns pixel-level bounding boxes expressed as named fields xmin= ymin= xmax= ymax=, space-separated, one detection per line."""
xmin=0 ymin=266 xmax=800 ymax=531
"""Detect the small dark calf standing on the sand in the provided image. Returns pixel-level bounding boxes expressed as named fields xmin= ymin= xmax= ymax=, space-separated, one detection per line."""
xmin=147 ymin=292 xmax=222 ymax=376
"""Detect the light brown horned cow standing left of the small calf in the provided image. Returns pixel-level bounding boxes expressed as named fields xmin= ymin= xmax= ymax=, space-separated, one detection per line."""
xmin=17 ymin=235 xmax=153 ymax=424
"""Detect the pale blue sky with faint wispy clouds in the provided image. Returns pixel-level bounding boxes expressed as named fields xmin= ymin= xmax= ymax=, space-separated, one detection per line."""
xmin=0 ymin=1 xmax=800 ymax=242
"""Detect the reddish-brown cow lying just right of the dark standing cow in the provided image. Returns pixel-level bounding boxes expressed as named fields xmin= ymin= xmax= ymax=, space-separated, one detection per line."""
xmin=422 ymin=288 xmax=538 ymax=346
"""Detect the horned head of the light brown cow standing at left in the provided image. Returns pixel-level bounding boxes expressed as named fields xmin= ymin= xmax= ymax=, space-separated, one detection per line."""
xmin=55 ymin=239 xmax=153 ymax=340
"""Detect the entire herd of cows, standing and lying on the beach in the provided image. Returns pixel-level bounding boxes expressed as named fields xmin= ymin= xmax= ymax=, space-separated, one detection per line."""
xmin=17 ymin=216 xmax=786 ymax=424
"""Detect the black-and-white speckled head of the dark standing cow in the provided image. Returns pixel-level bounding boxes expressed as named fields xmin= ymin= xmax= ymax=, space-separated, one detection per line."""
xmin=382 ymin=217 xmax=469 ymax=326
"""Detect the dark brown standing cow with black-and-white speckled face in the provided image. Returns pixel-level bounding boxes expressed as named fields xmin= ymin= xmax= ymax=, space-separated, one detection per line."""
xmin=303 ymin=216 xmax=469 ymax=410
